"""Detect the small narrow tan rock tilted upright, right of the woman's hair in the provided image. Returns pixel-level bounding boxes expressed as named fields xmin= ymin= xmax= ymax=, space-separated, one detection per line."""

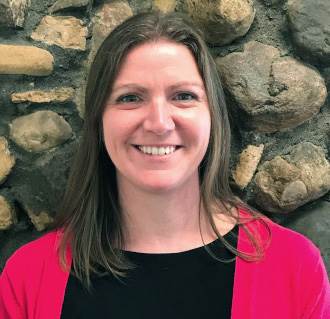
xmin=232 ymin=144 xmax=264 ymax=189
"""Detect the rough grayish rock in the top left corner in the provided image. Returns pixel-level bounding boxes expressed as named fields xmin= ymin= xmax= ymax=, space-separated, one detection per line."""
xmin=0 ymin=0 xmax=30 ymax=27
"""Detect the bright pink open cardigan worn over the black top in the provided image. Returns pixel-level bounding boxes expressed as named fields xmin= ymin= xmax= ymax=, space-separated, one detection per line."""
xmin=0 ymin=212 xmax=330 ymax=319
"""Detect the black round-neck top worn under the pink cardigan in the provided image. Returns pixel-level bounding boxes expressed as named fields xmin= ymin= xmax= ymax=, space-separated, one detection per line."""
xmin=61 ymin=225 xmax=238 ymax=319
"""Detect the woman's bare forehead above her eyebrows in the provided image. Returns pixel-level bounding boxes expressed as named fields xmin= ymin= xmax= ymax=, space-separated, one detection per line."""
xmin=115 ymin=39 xmax=203 ymax=86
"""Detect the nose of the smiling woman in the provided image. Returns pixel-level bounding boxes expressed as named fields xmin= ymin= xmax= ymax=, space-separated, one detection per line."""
xmin=143 ymin=98 xmax=175 ymax=135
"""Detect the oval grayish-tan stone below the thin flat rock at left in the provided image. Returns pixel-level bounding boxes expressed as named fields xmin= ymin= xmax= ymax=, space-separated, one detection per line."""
xmin=9 ymin=111 xmax=72 ymax=152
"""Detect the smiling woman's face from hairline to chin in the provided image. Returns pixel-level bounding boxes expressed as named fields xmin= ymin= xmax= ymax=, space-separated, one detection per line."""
xmin=103 ymin=40 xmax=211 ymax=192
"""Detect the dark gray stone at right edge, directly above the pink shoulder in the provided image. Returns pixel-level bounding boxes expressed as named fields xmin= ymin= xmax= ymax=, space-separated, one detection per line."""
xmin=285 ymin=200 xmax=330 ymax=275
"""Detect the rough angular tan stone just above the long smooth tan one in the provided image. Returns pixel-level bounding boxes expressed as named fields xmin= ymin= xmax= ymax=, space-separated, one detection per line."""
xmin=31 ymin=16 xmax=88 ymax=51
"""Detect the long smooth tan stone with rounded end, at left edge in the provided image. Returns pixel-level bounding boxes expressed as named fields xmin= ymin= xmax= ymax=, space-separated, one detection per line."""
xmin=0 ymin=44 xmax=54 ymax=76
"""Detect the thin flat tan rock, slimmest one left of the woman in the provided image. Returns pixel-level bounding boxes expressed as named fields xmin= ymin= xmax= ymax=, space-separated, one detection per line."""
xmin=11 ymin=87 xmax=75 ymax=103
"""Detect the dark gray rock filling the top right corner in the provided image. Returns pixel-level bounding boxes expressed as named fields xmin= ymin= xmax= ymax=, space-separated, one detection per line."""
xmin=287 ymin=0 xmax=330 ymax=65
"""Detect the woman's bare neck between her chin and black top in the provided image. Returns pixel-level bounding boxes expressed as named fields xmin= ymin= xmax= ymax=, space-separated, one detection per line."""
xmin=118 ymin=176 xmax=236 ymax=252
